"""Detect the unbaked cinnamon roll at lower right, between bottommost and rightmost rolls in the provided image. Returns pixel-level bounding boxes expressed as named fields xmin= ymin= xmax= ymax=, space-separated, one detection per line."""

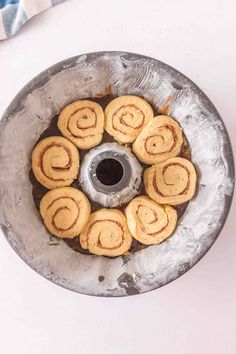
xmin=125 ymin=196 xmax=177 ymax=245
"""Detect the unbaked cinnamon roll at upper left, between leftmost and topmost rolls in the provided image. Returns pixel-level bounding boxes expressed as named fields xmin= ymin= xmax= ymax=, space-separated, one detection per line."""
xmin=57 ymin=100 xmax=104 ymax=149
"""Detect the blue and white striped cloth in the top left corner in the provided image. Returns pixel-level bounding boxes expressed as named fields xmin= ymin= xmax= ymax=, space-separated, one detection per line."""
xmin=0 ymin=0 xmax=64 ymax=40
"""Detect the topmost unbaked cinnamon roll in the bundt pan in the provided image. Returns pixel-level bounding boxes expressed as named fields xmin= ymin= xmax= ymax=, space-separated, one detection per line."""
xmin=105 ymin=96 xmax=153 ymax=144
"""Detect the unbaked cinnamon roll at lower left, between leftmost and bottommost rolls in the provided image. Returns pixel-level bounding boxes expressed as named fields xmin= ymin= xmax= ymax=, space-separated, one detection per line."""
xmin=40 ymin=187 xmax=91 ymax=238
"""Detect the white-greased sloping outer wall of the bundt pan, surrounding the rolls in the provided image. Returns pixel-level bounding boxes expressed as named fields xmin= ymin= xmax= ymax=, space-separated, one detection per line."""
xmin=0 ymin=52 xmax=234 ymax=296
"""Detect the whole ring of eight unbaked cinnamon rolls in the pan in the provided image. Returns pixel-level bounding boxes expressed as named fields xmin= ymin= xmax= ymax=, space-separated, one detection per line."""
xmin=32 ymin=96 xmax=197 ymax=257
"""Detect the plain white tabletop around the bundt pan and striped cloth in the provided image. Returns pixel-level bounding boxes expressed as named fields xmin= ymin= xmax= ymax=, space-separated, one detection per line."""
xmin=0 ymin=0 xmax=236 ymax=354
